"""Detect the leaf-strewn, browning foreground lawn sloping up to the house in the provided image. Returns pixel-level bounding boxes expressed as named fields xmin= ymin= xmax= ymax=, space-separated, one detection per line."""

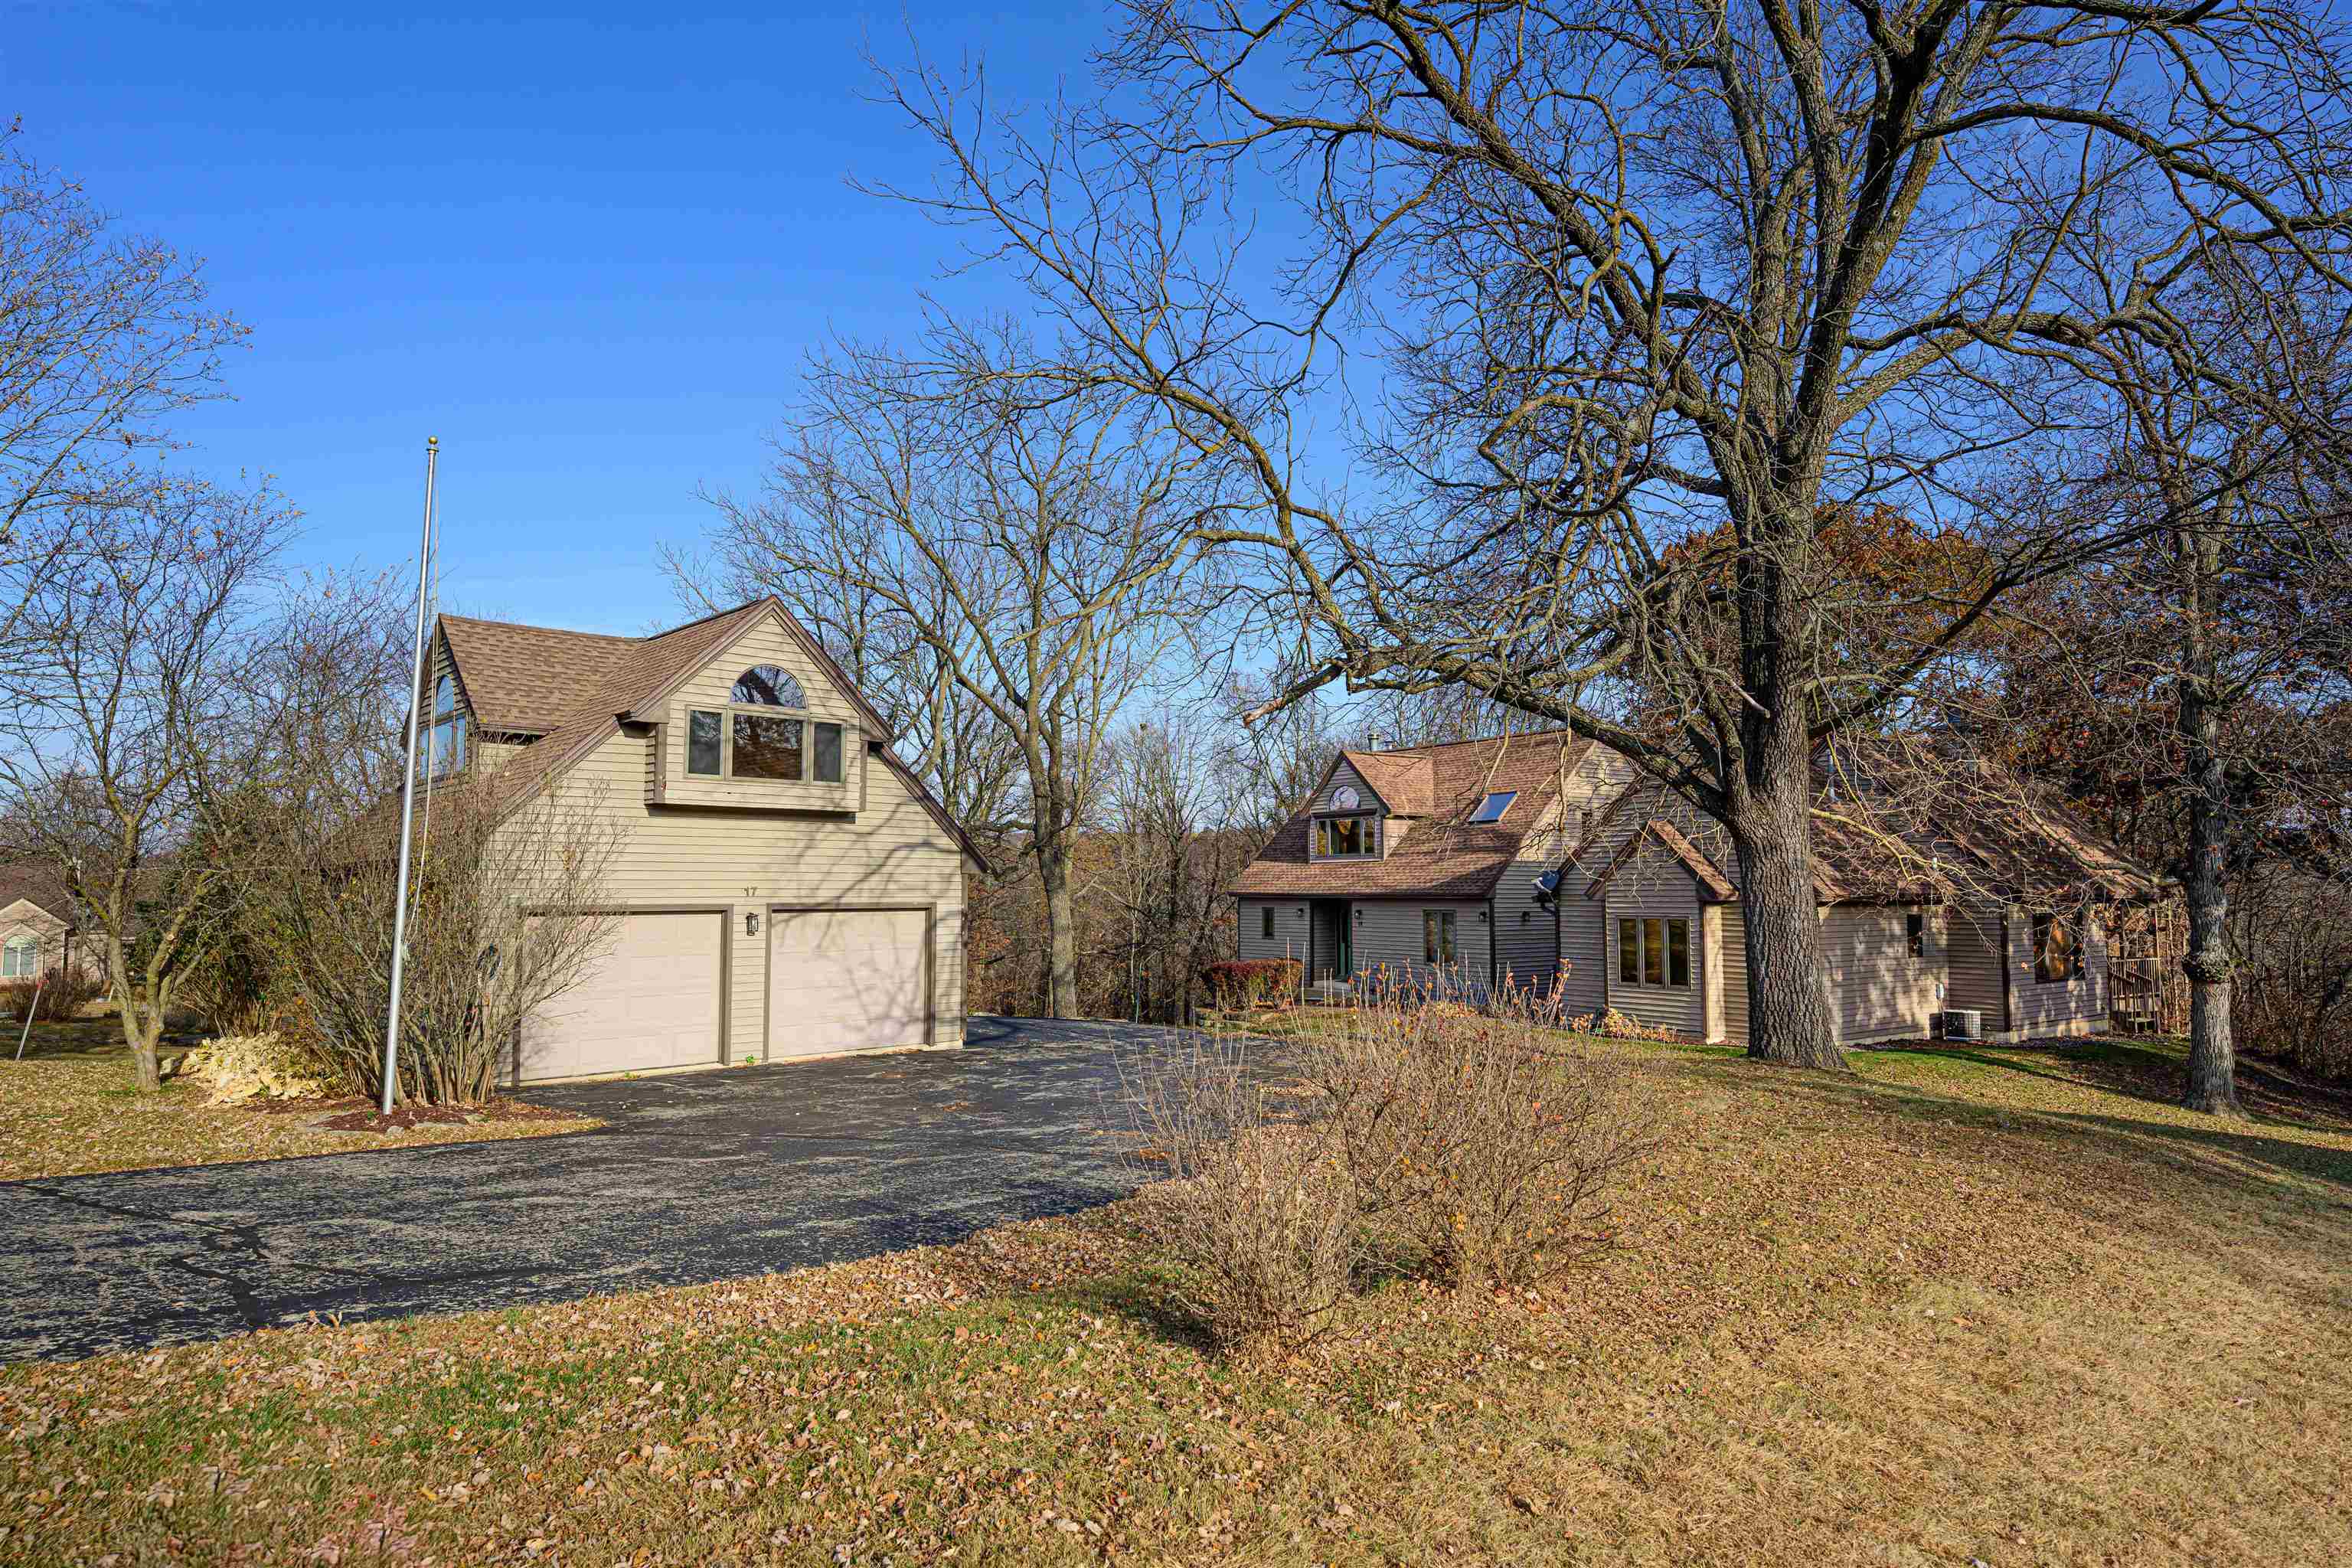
xmin=0 ymin=1044 xmax=2352 ymax=1568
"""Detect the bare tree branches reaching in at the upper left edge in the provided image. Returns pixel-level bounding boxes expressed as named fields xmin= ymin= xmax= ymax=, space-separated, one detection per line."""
xmin=0 ymin=127 xmax=244 ymax=648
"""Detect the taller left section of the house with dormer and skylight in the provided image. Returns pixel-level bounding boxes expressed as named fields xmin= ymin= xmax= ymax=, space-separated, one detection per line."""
xmin=1233 ymin=731 xmax=1632 ymax=995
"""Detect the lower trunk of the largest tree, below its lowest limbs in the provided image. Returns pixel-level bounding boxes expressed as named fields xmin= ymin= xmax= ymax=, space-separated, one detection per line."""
xmin=1731 ymin=778 xmax=1847 ymax=1067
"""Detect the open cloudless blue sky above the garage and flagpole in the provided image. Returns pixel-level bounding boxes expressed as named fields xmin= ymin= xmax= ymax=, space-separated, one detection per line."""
xmin=0 ymin=0 xmax=1101 ymax=632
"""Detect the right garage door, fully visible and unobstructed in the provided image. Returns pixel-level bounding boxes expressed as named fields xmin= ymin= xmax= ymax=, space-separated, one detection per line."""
xmin=766 ymin=910 xmax=929 ymax=1056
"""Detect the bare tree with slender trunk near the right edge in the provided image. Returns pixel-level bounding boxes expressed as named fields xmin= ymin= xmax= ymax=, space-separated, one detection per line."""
xmin=1966 ymin=276 xmax=2352 ymax=1114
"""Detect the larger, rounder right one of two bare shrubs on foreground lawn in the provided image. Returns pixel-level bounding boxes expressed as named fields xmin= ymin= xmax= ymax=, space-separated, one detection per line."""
xmin=1301 ymin=1004 xmax=1648 ymax=1289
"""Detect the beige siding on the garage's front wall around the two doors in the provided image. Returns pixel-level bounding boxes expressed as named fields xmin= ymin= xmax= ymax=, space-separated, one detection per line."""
xmin=534 ymin=619 xmax=965 ymax=1060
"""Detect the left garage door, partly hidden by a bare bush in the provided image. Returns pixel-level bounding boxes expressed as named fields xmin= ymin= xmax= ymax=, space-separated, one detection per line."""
xmin=520 ymin=912 xmax=727 ymax=1081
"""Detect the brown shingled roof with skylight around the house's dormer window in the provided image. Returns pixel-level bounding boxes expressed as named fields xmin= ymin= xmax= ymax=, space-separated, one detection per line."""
xmin=1228 ymin=729 xmax=1592 ymax=900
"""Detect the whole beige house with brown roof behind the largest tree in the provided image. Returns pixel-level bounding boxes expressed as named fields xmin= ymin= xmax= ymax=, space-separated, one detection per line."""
xmin=1233 ymin=731 xmax=2161 ymax=1044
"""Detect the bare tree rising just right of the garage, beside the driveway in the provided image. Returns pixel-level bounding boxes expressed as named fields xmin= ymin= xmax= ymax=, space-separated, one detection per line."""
xmin=673 ymin=325 xmax=1202 ymax=1018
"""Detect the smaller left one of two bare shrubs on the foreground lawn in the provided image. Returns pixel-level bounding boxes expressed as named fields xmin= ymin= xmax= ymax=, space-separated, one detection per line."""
xmin=1124 ymin=1034 xmax=1360 ymax=1357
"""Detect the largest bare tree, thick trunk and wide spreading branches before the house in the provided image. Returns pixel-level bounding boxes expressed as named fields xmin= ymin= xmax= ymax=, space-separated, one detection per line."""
xmin=884 ymin=0 xmax=2352 ymax=1065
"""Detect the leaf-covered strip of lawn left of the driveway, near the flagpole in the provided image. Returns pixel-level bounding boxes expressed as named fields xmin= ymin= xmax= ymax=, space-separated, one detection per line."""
xmin=0 ymin=1018 xmax=599 ymax=1175
